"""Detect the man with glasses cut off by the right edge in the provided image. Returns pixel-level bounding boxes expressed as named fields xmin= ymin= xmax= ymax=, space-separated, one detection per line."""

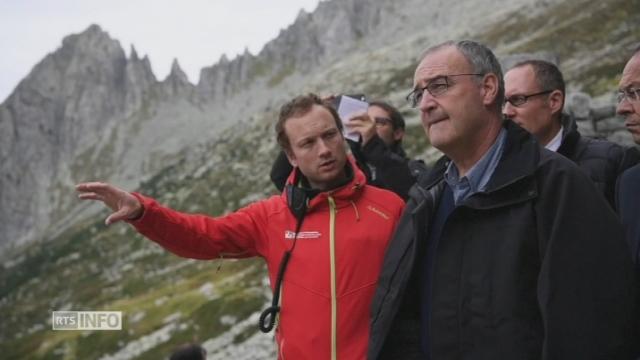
xmin=617 ymin=47 xmax=640 ymax=266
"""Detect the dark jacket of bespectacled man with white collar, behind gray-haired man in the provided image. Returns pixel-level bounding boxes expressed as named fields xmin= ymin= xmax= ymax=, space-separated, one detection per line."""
xmin=558 ymin=115 xmax=638 ymax=209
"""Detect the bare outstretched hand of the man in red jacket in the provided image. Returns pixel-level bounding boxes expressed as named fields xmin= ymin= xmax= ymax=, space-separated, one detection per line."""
xmin=76 ymin=182 xmax=143 ymax=225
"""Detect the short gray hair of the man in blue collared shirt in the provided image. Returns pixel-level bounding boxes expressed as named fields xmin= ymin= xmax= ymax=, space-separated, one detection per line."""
xmin=422 ymin=40 xmax=504 ymax=115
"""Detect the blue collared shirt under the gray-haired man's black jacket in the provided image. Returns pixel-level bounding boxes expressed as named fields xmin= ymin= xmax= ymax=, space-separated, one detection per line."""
xmin=444 ymin=128 xmax=507 ymax=206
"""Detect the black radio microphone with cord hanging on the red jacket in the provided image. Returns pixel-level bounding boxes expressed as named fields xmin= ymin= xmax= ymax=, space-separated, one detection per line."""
xmin=258 ymin=184 xmax=309 ymax=333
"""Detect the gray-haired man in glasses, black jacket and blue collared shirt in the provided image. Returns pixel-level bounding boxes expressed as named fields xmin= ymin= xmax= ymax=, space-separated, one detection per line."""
xmin=368 ymin=41 xmax=635 ymax=359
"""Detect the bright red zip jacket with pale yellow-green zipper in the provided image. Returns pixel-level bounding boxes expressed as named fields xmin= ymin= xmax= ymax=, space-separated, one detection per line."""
xmin=127 ymin=165 xmax=404 ymax=360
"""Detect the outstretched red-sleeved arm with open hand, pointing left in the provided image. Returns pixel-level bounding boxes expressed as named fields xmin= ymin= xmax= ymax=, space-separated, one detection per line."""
xmin=76 ymin=182 xmax=266 ymax=259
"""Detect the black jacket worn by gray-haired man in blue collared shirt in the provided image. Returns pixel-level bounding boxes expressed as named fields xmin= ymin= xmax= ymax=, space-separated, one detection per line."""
xmin=368 ymin=121 xmax=635 ymax=360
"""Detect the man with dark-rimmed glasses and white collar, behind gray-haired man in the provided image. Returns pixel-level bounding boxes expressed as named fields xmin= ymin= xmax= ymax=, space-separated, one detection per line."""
xmin=502 ymin=60 xmax=637 ymax=209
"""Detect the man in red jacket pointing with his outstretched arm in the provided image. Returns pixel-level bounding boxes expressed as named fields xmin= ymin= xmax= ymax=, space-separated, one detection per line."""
xmin=76 ymin=94 xmax=404 ymax=359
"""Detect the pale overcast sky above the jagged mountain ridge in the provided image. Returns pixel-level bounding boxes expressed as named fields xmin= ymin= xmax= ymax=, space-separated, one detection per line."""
xmin=0 ymin=0 xmax=318 ymax=103
